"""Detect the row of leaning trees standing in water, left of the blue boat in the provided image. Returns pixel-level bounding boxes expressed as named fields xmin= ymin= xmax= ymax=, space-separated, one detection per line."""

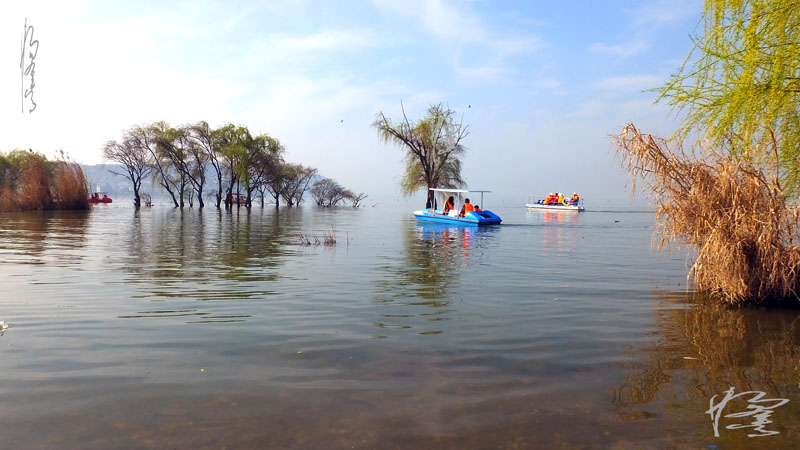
xmin=103 ymin=121 xmax=366 ymax=208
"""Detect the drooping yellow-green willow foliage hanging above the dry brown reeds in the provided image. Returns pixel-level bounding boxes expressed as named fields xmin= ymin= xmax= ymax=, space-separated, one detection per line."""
xmin=660 ymin=0 xmax=800 ymax=192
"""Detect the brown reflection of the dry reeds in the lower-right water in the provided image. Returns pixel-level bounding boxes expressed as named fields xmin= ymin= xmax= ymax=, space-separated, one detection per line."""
xmin=612 ymin=293 xmax=800 ymax=442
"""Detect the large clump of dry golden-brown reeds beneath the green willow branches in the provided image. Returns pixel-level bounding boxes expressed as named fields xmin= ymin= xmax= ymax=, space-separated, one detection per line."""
xmin=616 ymin=124 xmax=800 ymax=304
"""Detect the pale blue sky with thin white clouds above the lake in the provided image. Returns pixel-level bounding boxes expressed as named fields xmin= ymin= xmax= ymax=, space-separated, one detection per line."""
xmin=0 ymin=0 xmax=702 ymax=204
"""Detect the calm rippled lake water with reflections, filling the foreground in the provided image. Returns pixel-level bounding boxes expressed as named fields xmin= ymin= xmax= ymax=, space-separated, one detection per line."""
xmin=0 ymin=202 xmax=800 ymax=449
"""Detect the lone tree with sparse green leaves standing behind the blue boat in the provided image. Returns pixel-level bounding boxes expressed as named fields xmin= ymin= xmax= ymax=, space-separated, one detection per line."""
xmin=372 ymin=103 xmax=469 ymax=208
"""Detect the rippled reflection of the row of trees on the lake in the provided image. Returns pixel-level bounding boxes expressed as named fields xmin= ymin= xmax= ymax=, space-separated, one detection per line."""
xmin=114 ymin=209 xmax=300 ymax=322
